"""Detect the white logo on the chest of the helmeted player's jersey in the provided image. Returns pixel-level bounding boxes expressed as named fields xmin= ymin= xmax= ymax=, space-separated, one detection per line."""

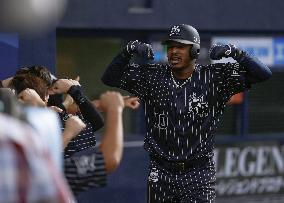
xmin=188 ymin=93 xmax=208 ymax=118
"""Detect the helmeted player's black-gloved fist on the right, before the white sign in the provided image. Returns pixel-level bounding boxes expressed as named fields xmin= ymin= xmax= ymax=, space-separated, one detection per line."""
xmin=209 ymin=44 xmax=238 ymax=60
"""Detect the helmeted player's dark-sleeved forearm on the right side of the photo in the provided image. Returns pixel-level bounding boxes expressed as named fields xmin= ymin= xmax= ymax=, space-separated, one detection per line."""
xmin=237 ymin=52 xmax=272 ymax=83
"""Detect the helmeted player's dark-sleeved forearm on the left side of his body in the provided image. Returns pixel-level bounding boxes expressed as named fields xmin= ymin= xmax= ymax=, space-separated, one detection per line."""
xmin=101 ymin=52 xmax=131 ymax=87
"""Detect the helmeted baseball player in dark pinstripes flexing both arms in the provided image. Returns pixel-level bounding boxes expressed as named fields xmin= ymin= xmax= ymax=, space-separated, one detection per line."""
xmin=102 ymin=24 xmax=271 ymax=203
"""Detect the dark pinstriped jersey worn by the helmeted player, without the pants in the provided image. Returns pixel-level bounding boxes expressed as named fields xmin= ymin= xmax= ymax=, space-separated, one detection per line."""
xmin=120 ymin=63 xmax=250 ymax=161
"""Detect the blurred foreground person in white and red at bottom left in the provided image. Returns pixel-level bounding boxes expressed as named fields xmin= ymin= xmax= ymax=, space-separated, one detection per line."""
xmin=0 ymin=89 xmax=74 ymax=203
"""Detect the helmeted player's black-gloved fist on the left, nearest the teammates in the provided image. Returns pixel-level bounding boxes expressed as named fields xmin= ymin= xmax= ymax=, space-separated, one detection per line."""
xmin=124 ymin=40 xmax=154 ymax=60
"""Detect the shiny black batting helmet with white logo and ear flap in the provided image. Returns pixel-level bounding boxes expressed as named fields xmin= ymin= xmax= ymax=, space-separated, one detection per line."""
xmin=162 ymin=24 xmax=200 ymax=59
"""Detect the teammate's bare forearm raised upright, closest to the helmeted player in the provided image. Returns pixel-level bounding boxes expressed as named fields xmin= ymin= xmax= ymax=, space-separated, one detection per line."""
xmin=100 ymin=108 xmax=123 ymax=173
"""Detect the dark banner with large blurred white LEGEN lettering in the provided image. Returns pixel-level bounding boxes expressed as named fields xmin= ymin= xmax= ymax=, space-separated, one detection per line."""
xmin=214 ymin=142 xmax=284 ymax=197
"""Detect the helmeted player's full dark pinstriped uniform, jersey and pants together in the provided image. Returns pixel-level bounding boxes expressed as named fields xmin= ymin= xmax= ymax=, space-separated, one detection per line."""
xmin=120 ymin=63 xmax=250 ymax=203
